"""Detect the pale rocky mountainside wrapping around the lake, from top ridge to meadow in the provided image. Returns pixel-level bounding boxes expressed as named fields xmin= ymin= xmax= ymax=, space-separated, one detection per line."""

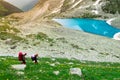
xmin=0 ymin=0 xmax=120 ymax=62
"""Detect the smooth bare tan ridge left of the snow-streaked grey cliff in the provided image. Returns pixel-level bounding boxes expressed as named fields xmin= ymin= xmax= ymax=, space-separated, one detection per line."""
xmin=10 ymin=0 xmax=64 ymax=22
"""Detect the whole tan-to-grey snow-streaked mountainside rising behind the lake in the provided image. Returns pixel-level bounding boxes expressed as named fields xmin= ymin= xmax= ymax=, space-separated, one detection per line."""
xmin=8 ymin=0 xmax=120 ymax=22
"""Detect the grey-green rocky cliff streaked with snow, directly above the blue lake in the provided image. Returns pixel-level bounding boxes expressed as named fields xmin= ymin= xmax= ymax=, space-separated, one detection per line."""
xmin=58 ymin=0 xmax=120 ymax=19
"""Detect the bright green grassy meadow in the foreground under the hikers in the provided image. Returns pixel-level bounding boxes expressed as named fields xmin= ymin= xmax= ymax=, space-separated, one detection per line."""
xmin=0 ymin=57 xmax=120 ymax=80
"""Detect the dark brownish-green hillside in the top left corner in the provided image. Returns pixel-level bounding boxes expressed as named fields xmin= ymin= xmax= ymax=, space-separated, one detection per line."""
xmin=0 ymin=0 xmax=22 ymax=16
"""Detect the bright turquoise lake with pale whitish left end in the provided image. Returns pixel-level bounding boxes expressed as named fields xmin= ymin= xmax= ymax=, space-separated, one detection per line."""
xmin=54 ymin=18 xmax=120 ymax=38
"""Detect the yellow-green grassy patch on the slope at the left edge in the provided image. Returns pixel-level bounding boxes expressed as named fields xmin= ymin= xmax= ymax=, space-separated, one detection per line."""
xmin=0 ymin=20 xmax=26 ymax=44
